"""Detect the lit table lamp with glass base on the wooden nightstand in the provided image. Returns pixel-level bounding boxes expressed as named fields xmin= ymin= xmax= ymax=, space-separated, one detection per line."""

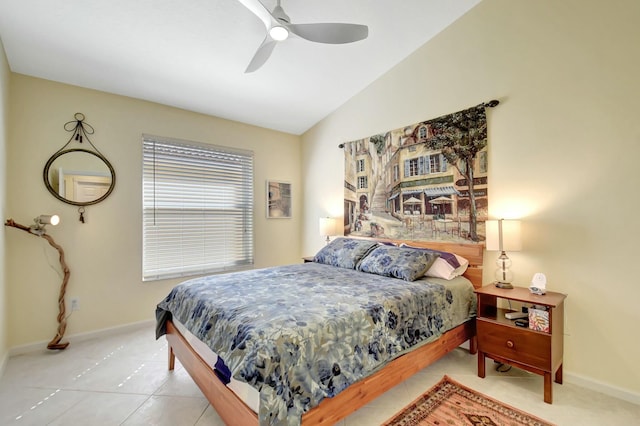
xmin=485 ymin=219 xmax=522 ymax=288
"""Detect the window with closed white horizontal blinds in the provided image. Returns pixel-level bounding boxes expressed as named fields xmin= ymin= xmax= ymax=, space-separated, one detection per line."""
xmin=142 ymin=135 xmax=253 ymax=281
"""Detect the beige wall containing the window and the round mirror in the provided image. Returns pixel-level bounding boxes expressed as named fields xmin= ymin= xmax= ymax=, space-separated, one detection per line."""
xmin=6 ymin=74 xmax=301 ymax=347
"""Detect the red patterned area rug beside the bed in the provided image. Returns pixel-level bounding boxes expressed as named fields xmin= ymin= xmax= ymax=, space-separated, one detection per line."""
xmin=384 ymin=376 xmax=553 ymax=426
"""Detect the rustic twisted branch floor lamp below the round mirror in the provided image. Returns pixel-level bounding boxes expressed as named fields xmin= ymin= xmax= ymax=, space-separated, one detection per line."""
xmin=4 ymin=215 xmax=71 ymax=350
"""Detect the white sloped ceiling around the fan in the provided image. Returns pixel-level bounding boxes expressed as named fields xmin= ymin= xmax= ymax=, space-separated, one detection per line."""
xmin=0 ymin=0 xmax=481 ymax=134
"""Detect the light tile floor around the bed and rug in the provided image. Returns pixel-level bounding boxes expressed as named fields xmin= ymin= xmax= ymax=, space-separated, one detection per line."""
xmin=0 ymin=327 xmax=640 ymax=426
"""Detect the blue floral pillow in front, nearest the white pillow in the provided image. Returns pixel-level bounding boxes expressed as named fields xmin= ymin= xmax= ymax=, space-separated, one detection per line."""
xmin=357 ymin=245 xmax=439 ymax=281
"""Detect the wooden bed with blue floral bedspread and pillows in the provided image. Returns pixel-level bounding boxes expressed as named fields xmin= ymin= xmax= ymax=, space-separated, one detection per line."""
xmin=156 ymin=238 xmax=483 ymax=425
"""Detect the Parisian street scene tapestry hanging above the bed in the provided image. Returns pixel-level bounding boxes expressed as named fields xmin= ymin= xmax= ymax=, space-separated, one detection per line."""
xmin=344 ymin=104 xmax=488 ymax=242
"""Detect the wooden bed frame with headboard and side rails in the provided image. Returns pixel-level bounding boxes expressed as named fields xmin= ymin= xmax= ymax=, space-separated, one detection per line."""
xmin=166 ymin=239 xmax=484 ymax=426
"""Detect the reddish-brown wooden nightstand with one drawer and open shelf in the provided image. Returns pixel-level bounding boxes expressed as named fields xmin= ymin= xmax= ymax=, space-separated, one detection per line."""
xmin=476 ymin=285 xmax=566 ymax=404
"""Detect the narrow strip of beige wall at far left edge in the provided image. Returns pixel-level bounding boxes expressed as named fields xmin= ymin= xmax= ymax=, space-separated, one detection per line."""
xmin=0 ymin=40 xmax=11 ymax=368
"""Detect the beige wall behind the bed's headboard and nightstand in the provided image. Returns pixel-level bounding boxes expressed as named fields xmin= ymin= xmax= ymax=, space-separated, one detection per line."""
xmin=302 ymin=0 xmax=640 ymax=402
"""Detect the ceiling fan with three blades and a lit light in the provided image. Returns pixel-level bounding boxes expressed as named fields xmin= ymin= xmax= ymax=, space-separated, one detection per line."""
xmin=238 ymin=0 xmax=369 ymax=73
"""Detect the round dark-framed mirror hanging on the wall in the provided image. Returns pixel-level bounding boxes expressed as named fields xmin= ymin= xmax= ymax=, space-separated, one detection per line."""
xmin=43 ymin=148 xmax=116 ymax=206
